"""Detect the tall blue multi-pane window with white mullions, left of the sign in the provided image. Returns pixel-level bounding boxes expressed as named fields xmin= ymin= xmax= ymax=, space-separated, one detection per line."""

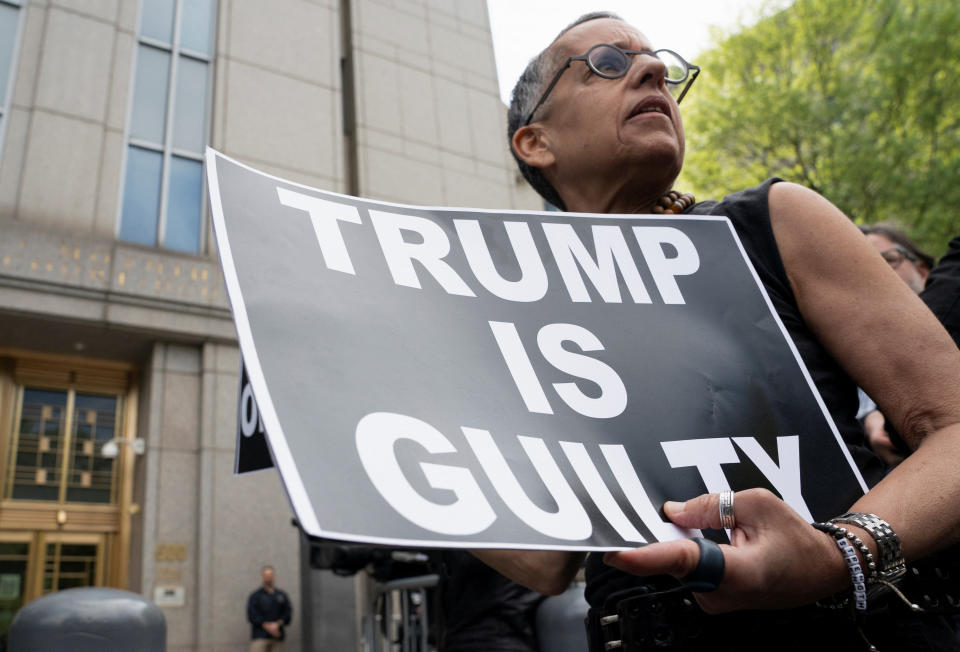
xmin=119 ymin=0 xmax=216 ymax=253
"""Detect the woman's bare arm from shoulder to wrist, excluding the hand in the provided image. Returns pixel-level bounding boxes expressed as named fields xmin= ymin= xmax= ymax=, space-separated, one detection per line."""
xmin=770 ymin=184 xmax=960 ymax=559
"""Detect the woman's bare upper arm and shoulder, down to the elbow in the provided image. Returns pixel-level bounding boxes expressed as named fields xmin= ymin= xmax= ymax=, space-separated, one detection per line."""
xmin=769 ymin=183 xmax=960 ymax=445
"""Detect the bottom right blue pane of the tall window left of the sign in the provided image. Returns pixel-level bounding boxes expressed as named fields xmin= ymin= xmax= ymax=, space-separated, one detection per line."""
xmin=163 ymin=156 xmax=203 ymax=254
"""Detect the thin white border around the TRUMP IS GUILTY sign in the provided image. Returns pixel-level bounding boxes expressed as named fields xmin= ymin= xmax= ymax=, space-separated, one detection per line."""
xmin=205 ymin=147 xmax=867 ymax=551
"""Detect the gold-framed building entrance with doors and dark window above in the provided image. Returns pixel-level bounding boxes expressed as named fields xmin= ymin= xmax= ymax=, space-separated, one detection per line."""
xmin=0 ymin=351 xmax=137 ymax=637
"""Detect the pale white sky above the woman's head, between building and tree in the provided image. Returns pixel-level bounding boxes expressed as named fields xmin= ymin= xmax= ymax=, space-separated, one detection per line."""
xmin=487 ymin=0 xmax=789 ymax=104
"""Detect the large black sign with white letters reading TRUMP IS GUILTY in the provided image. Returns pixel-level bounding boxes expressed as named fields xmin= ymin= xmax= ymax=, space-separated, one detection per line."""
xmin=207 ymin=150 xmax=865 ymax=550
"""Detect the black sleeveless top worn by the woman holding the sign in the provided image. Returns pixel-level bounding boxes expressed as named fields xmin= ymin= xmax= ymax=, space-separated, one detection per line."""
xmin=585 ymin=178 xmax=884 ymax=607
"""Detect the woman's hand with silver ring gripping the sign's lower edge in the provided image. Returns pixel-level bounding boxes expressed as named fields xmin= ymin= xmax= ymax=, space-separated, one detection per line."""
xmin=604 ymin=489 xmax=850 ymax=613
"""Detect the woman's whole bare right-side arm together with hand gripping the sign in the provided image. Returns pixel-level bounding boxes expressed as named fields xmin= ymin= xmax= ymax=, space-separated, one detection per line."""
xmin=608 ymin=183 xmax=960 ymax=612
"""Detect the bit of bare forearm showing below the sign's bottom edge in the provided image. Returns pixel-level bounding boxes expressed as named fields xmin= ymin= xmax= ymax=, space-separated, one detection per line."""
xmin=470 ymin=550 xmax=584 ymax=595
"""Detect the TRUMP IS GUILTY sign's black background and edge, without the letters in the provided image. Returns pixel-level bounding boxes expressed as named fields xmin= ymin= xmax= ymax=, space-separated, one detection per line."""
xmin=207 ymin=151 xmax=863 ymax=549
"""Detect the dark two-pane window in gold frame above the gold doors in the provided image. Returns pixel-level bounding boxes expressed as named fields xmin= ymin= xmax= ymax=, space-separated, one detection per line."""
xmin=4 ymin=387 xmax=120 ymax=504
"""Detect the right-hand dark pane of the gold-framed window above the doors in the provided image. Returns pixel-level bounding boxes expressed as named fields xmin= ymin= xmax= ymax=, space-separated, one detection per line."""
xmin=67 ymin=393 xmax=122 ymax=503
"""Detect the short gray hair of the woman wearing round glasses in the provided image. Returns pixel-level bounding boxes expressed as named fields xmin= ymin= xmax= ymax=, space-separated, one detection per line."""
xmin=507 ymin=11 xmax=623 ymax=210
